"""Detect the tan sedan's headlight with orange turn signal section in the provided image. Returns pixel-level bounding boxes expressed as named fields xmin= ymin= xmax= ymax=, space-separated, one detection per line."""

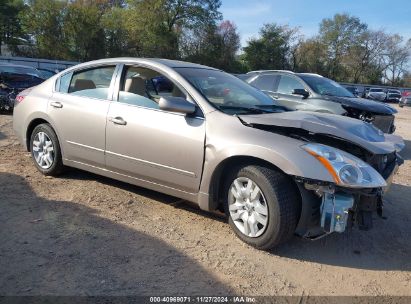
xmin=302 ymin=144 xmax=386 ymax=188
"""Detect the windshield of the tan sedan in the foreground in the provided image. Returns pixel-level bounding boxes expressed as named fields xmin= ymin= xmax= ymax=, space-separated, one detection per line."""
xmin=175 ymin=68 xmax=285 ymax=114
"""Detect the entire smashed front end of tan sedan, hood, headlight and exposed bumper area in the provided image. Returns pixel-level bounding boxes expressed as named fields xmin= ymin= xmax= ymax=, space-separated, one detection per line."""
xmin=240 ymin=113 xmax=404 ymax=239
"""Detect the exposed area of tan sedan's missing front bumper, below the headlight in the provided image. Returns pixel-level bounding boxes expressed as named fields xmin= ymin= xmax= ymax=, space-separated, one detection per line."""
xmin=296 ymin=155 xmax=404 ymax=239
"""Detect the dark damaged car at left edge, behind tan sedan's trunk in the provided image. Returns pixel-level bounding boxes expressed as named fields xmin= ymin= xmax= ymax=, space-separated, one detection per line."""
xmin=0 ymin=63 xmax=44 ymax=111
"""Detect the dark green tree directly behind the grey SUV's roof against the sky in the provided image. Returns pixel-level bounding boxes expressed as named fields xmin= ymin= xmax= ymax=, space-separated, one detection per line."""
xmin=243 ymin=23 xmax=298 ymax=70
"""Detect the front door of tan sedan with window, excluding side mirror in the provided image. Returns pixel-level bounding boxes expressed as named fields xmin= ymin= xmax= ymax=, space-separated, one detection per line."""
xmin=106 ymin=65 xmax=205 ymax=193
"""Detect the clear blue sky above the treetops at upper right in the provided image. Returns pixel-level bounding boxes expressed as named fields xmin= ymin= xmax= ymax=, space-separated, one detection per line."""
xmin=220 ymin=0 xmax=411 ymax=46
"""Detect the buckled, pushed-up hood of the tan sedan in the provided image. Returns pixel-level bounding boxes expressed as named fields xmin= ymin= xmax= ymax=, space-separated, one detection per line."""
xmin=239 ymin=111 xmax=405 ymax=154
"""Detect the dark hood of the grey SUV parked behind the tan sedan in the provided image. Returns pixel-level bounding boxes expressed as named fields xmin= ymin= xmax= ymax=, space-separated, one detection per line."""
xmin=326 ymin=96 xmax=397 ymax=115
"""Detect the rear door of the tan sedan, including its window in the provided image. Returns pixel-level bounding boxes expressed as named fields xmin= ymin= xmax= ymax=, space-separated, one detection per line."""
xmin=48 ymin=65 xmax=116 ymax=167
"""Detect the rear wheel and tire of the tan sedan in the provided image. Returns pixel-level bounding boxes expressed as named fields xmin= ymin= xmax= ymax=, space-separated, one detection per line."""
xmin=30 ymin=124 xmax=64 ymax=176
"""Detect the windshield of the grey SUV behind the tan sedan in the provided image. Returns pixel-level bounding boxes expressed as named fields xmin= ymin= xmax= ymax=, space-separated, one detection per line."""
xmin=300 ymin=75 xmax=355 ymax=97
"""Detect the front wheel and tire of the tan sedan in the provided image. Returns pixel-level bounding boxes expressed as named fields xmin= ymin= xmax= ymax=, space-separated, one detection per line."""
xmin=224 ymin=165 xmax=301 ymax=250
